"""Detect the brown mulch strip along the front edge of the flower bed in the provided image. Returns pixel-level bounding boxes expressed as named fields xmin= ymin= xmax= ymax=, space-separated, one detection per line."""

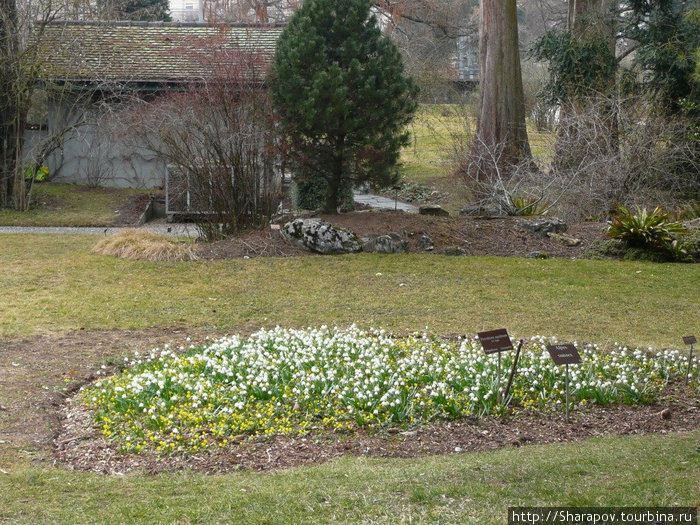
xmin=55 ymin=378 xmax=700 ymax=474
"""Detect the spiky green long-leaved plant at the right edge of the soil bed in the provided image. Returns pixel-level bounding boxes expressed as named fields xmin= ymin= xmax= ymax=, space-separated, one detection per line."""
xmin=608 ymin=205 xmax=689 ymax=261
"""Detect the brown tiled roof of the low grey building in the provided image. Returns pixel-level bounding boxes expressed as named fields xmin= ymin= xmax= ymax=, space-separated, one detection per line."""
xmin=40 ymin=22 xmax=283 ymax=84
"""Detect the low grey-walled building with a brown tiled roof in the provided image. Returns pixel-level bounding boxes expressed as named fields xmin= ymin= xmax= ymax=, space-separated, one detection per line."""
xmin=33 ymin=21 xmax=282 ymax=188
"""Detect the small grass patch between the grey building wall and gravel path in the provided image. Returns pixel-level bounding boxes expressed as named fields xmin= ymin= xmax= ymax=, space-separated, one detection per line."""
xmin=0 ymin=182 xmax=150 ymax=226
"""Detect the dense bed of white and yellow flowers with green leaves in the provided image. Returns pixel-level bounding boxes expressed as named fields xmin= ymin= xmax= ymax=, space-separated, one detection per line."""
xmin=81 ymin=326 xmax=700 ymax=453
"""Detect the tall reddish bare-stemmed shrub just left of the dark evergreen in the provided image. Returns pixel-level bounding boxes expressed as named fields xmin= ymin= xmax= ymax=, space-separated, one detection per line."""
xmin=123 ymin=46 xmax=280 ymax=240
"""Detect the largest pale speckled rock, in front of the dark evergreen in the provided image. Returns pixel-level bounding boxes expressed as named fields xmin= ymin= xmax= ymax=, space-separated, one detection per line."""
xmin=280 ymin=219 xmax=362 ymax=254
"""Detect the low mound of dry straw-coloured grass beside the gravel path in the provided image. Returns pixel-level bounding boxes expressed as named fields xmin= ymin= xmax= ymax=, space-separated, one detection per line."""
xmin=92 ymin=229 xmax=198 ymax=261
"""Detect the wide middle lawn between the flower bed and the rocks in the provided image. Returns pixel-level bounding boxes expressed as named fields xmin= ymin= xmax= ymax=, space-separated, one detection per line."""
xmin=0 ymin=235 xmax=700 ymax=347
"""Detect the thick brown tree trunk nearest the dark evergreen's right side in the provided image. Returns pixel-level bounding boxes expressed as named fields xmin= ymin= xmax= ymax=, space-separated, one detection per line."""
xmin=475 ymin=0 xmax=531 ymax=166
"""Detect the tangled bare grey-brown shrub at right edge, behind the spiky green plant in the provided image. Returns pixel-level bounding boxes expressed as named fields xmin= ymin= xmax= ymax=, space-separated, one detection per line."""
xmin=540 ymin=99 xmax=700 ymax=220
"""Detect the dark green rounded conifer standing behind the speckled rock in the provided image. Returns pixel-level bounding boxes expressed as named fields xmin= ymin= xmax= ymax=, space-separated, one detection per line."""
xmin=270 ymin=0 xmax=417 ymax=213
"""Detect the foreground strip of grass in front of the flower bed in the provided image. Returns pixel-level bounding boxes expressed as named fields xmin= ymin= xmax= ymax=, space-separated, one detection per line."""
xmin=0 ymin=431 xmax=700 ymax=524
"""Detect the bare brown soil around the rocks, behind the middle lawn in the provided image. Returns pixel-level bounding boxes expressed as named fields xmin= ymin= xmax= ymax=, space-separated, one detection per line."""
xmin=194 ymin=210 xmax=606 ymax=259
